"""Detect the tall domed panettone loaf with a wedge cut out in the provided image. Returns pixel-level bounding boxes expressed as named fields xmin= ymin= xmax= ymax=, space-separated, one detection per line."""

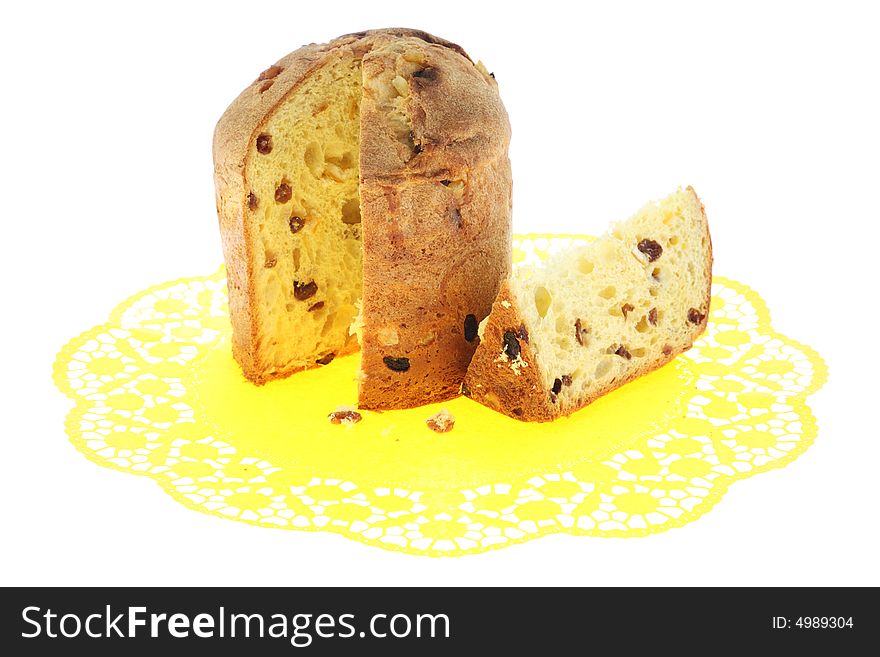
xmin=214 ymin=29 xmax=511 ymax=408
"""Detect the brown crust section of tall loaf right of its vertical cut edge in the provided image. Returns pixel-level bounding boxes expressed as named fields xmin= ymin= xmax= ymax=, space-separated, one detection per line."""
xmin=359 ymin=38 xmax=511 ymax=409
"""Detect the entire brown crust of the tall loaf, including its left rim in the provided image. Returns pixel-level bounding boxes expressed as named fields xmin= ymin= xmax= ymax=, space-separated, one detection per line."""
xmin=213 ymin=28 xmax=511 ymax=390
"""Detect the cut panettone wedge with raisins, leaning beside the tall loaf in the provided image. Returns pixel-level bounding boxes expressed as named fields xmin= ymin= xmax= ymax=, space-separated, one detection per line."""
xmin=462 ymin=187 xmax=712 ymax=421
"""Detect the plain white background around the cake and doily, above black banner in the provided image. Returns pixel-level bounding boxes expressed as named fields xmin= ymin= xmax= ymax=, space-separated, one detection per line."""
xmin=0 ymin=0 xmax=880 ymax=585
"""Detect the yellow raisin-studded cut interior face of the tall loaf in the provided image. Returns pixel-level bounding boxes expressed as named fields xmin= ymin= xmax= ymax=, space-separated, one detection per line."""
xmin=245 ymin=57 xmax=363 ymax=376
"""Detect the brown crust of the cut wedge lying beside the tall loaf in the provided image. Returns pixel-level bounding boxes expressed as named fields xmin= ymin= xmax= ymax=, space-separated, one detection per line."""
xmin=462 ymin=187 xmax=713 ymax=422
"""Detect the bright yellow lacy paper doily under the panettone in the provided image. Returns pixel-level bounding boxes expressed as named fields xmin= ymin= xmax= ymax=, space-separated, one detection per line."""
xmin=54 ymin=235 xmax=826 ymax=556
